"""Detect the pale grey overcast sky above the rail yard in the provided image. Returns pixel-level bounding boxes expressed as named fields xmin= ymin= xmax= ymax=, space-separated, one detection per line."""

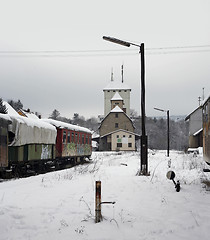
xmin=0 ymin=0 xmax=210 ymax=118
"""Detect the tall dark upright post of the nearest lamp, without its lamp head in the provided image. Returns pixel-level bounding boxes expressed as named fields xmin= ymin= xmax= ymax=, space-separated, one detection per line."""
xmin=140 ymin=43 xmax=148 ymax=175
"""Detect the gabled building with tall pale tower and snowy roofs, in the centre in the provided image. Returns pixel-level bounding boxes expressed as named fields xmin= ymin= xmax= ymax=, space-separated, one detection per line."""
xmin=97 ymin=74 xmax=140 ymax=151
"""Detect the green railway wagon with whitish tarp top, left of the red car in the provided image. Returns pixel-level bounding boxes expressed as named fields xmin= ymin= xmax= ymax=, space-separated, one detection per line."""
xmin=0 ymin=114 xmax=57 ymax=176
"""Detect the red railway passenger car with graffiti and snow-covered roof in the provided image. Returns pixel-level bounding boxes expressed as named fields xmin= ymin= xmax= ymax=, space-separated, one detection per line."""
xmin=42 ymin=119 xmax=92 ymax=165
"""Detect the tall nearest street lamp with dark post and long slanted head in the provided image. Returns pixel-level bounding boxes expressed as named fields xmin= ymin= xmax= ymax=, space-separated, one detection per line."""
xmin=103 ymin=36 xmax=149 ymax=175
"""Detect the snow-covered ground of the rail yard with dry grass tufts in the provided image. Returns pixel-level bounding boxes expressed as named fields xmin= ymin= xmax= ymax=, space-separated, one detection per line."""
xmin=0 ymin=151 xmax=210 ymax=240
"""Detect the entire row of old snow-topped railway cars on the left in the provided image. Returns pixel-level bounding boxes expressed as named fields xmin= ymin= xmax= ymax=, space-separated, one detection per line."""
xmin=0 ymin=109 xmax=92 ymax=178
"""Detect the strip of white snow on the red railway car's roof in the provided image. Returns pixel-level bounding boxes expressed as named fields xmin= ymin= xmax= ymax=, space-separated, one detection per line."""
xmin=41 ymin=119 xmax=92 ymax=133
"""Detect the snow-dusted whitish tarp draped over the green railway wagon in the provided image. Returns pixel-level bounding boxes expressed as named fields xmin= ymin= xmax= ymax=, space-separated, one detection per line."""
xmin=9 ymin=116 xmax=57 ymax=146
